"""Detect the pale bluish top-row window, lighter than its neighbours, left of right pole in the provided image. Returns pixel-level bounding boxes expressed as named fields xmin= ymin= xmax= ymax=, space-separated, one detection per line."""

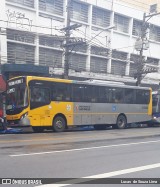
xmin=114 ymin=14 xmax=129 ymax=33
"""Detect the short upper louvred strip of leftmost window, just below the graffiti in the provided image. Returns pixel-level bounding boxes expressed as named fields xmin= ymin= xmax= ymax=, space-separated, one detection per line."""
xmin=7 ymin=29 xmax=35 ymax=44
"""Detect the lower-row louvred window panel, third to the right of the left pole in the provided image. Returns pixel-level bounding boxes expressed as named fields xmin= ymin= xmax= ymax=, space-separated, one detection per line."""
xmin=111 ymin=60 xmax=126 ymax=76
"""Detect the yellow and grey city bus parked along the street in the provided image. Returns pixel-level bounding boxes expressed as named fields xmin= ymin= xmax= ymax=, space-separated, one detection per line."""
xmin=6 ymin=76 xmax=152 ymax=132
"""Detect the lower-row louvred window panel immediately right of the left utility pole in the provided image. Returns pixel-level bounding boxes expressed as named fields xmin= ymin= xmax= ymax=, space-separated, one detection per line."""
xmin=69 ymin=54 xmax=86 ymax=72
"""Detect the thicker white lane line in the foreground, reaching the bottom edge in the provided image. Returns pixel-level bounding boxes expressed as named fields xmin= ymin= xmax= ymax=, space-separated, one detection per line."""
xmin=37 ymin=163 xmax=160 ymax=187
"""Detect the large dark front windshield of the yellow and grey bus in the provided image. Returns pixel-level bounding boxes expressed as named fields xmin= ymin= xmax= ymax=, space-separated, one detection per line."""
xmin=6 ymin=84 xmax=28 ymax=110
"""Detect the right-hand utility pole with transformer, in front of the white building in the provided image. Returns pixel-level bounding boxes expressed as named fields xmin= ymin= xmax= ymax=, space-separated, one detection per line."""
xmin=136 ymin=5 xmax=160 ymax=86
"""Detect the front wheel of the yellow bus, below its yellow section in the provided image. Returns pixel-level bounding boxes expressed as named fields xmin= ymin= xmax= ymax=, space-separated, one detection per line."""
xmin=53 ymin=116 xmax=66 ymax=132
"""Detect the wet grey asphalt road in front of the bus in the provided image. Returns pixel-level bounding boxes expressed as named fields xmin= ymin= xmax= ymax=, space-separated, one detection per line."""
xmin=0 ymin=127 xmax=160 ymax=187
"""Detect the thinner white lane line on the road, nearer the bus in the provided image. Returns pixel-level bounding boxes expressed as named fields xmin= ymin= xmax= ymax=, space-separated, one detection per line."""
xmin=10 ymin=140 xmax=160 ymax=157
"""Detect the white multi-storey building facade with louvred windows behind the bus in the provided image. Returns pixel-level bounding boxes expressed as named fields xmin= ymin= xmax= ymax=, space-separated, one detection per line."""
xmin=0 ymin=0 xmax=160 ymax=84
